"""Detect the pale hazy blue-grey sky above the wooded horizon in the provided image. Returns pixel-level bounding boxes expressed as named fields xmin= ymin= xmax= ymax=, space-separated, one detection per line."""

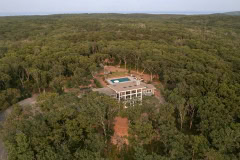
xmin=0 ymin=0 xmax=240 ymax=13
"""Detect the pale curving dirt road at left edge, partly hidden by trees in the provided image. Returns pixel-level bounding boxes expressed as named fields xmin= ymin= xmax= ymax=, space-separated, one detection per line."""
xmin=0 ymin=95 xmax=38 ymax=160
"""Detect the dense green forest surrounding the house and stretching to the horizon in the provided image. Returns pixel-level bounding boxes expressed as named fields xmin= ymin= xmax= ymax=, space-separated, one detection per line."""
xmin=0 ymin=14 xmax=240 ymax=160
